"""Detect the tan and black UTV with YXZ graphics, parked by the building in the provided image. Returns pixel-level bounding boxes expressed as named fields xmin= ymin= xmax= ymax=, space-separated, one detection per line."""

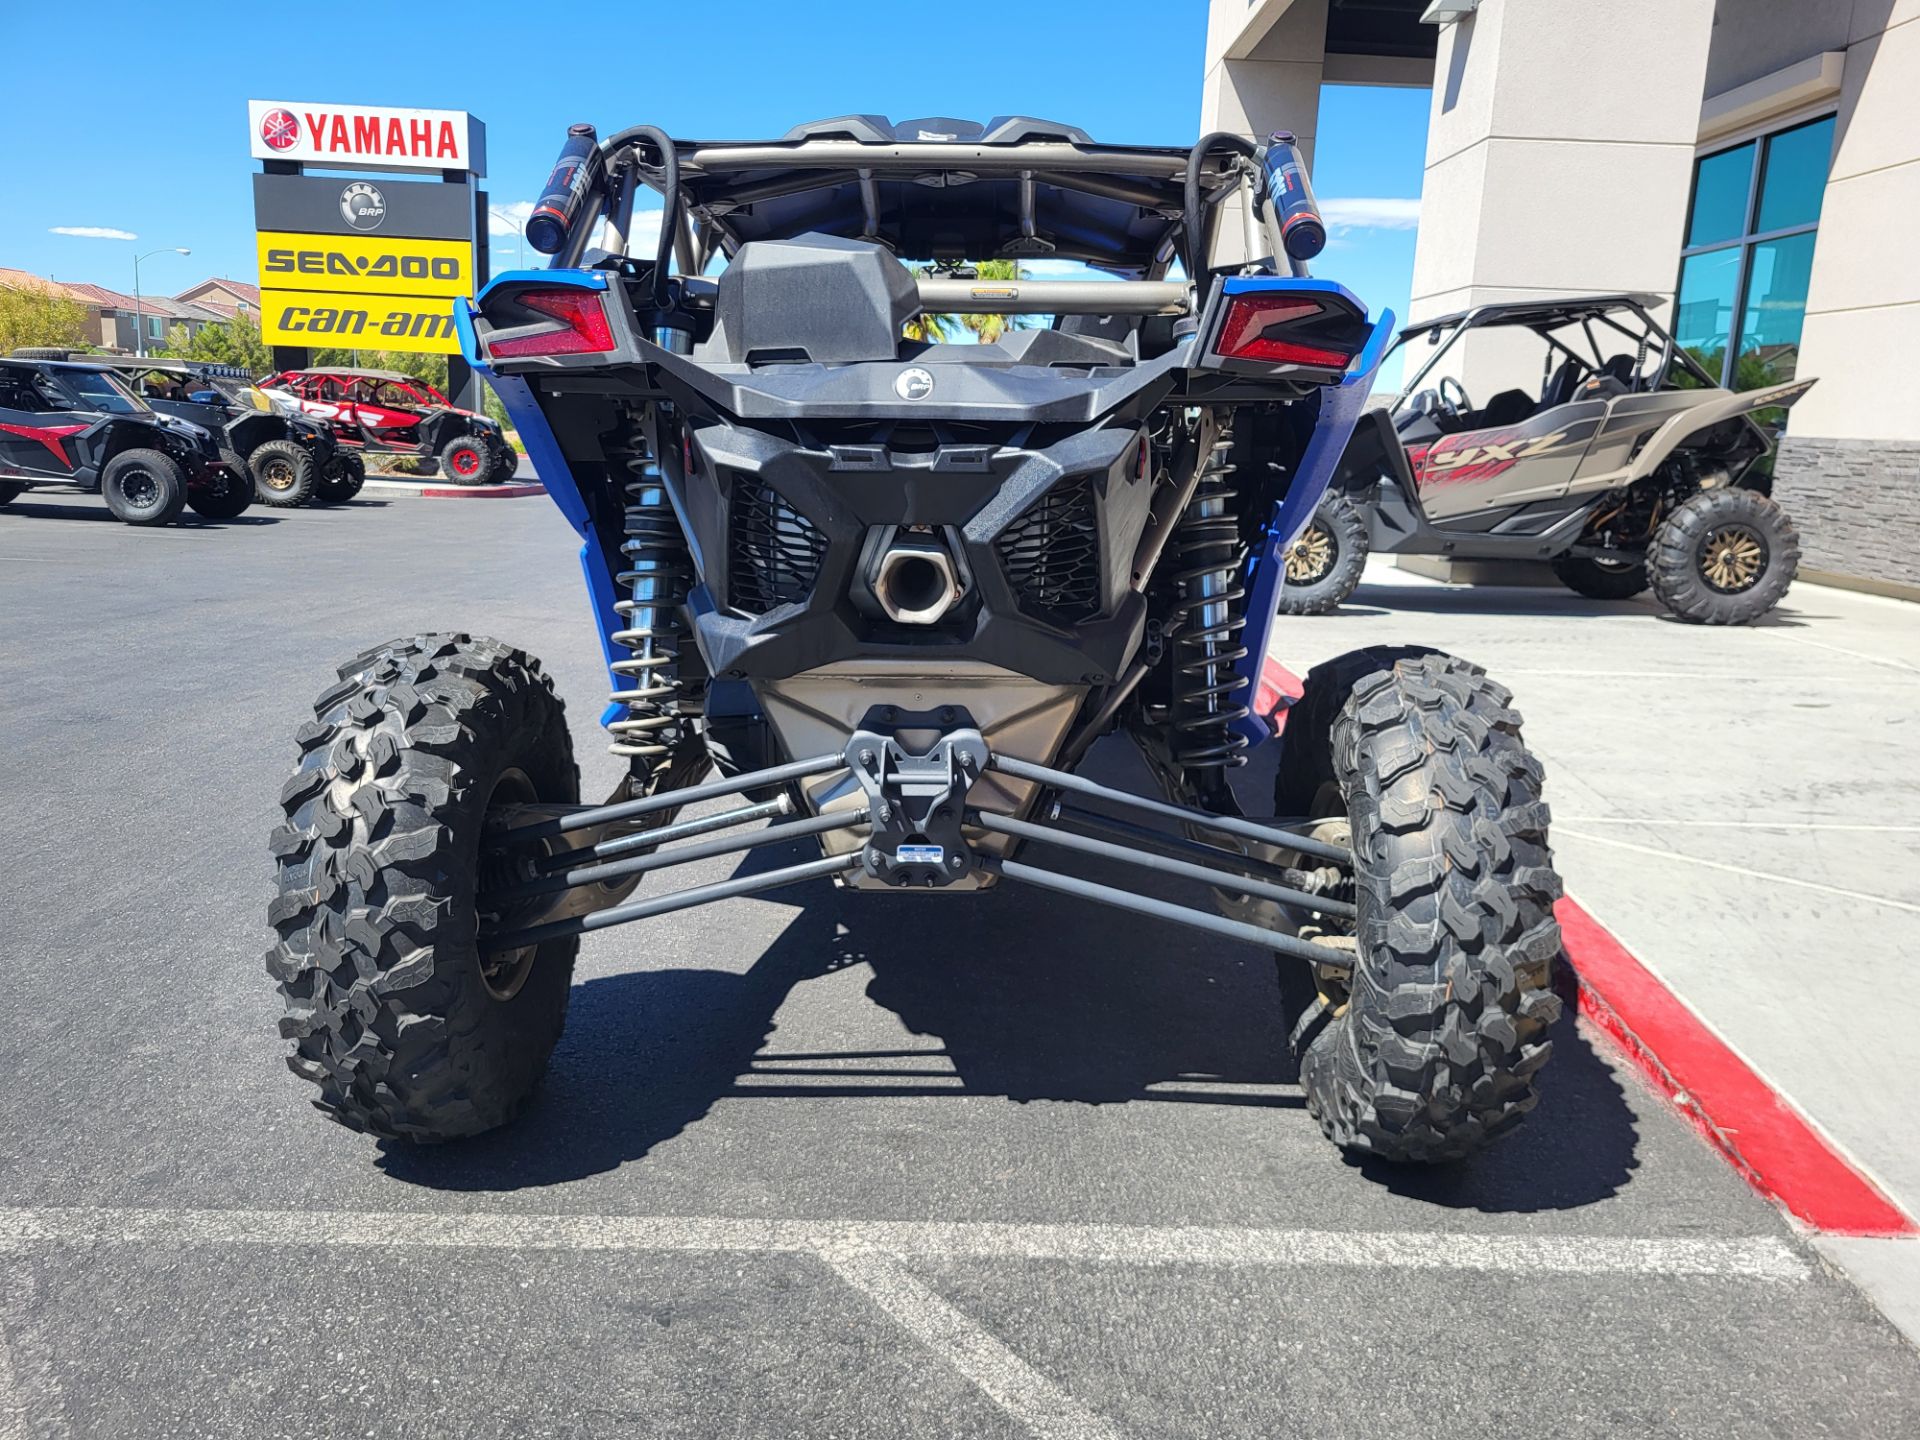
xmin=1281 ymin=294 xmax=1812 ymax=624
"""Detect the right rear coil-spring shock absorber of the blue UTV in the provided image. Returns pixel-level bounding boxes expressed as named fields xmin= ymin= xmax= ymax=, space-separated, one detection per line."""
xmin=1171 ymin=424 xmax=1248 ymax=772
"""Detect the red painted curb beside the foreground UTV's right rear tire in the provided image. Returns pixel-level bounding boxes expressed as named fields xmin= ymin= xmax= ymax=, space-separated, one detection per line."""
xmin=1555 ymin=899 xmax=1920 ymax=1235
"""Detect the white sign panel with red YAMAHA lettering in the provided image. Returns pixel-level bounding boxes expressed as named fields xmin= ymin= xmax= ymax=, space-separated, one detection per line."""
xmin=246 ymin=100 xmax=486 ymax=175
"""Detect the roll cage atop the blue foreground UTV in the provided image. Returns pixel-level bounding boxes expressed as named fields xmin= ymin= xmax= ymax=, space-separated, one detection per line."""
xmin=551 ymin=115 xmax=1306 ymax=305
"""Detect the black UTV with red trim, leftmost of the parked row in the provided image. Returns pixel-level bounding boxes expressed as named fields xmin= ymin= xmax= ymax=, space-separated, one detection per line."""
xmin=0 ymin=359 xmax=253 ymax=524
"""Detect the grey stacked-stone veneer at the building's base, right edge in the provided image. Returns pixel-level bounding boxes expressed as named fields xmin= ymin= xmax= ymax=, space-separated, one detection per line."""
xmin=1774 ymin=443 xmax=1920 ymax=586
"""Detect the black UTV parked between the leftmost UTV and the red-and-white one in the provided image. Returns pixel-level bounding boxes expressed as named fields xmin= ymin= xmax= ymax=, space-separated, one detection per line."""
xmin=73 ymin=355 xmax=353 ymax=507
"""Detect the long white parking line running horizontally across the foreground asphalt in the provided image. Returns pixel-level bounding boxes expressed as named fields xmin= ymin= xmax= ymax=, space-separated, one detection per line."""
xmin=0 ymin=1206 xmax=1809 ymax=1283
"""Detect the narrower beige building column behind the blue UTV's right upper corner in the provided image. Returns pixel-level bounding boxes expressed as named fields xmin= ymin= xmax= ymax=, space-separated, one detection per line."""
xmin=1196 ymin=0 xmax=1327 ymax=265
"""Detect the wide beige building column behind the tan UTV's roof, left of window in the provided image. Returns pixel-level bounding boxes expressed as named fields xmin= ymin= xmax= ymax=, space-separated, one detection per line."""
xmin=1411 ymin=0 xmax=1713 ymax=326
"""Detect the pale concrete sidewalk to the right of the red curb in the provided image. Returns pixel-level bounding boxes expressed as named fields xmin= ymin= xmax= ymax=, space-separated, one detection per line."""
xmin=1275 ymin=559 xmax=1920 ymax=1332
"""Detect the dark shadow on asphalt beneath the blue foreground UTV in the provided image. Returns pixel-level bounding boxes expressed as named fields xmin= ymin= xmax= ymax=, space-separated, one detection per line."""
xmin=378 ymin=829 xmax=1636 ymax=1212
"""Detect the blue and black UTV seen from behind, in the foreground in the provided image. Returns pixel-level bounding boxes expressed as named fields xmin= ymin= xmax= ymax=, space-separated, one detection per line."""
xmin=267 ymin=115 xmax=1559 ymax=1162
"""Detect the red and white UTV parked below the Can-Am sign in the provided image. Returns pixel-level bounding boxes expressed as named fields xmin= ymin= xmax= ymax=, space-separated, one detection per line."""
xmin=259 ymin=369 xmax=518 ymax=486
